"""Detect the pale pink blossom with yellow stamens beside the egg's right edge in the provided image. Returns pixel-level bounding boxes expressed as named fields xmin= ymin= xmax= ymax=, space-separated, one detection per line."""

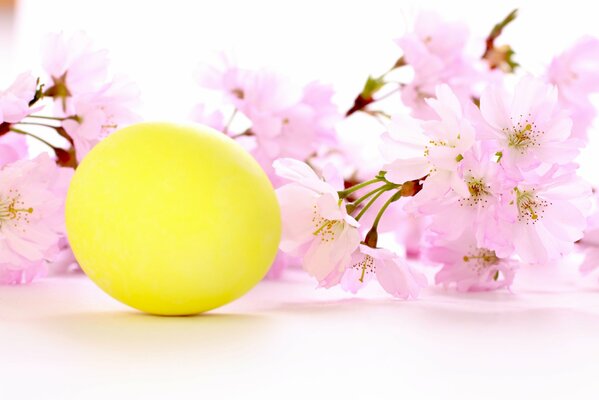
xmin=274 ymin=159 xmax=360 ymax=287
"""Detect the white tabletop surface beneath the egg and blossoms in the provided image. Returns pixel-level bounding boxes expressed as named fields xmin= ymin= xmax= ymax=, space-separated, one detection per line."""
xmin=0 ymin=273 xmax=599 ymax=399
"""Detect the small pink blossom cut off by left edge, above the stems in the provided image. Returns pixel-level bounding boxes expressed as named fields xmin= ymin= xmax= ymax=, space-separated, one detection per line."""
xmin=0 ymin=72 xmax=37 ymax=124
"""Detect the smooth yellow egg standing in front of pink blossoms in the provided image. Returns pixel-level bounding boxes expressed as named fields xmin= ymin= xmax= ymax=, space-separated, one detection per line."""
xmin=66 ymin=123 xmax=281 ymax=315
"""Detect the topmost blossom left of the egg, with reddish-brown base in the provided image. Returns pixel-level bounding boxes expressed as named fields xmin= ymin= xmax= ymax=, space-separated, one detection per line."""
xmin=42 ymin=32 xmax=108 ymax=112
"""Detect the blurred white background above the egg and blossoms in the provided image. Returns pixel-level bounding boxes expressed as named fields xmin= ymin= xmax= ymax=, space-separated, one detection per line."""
xmin=0 ymin=0 xmax=599 ymax=182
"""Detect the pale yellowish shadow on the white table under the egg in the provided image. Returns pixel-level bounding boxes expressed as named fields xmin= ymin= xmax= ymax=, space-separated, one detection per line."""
xmin=35 ymin=311 xmax=273 ymax=358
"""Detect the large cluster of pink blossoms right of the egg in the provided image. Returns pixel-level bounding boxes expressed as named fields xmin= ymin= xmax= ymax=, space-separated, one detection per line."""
xmin=201 ymin=11 xmax=599 ymax=299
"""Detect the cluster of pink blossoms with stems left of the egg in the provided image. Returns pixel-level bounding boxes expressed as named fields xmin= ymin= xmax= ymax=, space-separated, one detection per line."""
xmin=0 ymin=33 xmax=138 ymax=284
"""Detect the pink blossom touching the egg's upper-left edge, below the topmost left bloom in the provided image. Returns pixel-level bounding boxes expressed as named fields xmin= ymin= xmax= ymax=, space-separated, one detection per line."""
xmin=62 ymin=76 xmax=139 ymax=161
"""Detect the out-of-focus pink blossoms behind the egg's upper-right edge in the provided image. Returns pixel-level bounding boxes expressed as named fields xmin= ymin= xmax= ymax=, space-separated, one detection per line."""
xmin=194 ymin=56 xmax=340 ymax=181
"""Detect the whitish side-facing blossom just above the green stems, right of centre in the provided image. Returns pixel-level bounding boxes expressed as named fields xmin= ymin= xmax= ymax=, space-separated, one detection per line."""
xmin=381 ymin=85 xmax=475 ymax=201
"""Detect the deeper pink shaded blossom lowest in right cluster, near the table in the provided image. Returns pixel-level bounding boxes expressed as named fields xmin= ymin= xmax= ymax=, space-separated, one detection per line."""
xmin=424 ymin=232 xmax=517 ymax=292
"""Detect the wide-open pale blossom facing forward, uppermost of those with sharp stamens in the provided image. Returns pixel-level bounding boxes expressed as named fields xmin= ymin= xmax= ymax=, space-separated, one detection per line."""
xmin=480 ymin=76 xmax=578 ymax=175
